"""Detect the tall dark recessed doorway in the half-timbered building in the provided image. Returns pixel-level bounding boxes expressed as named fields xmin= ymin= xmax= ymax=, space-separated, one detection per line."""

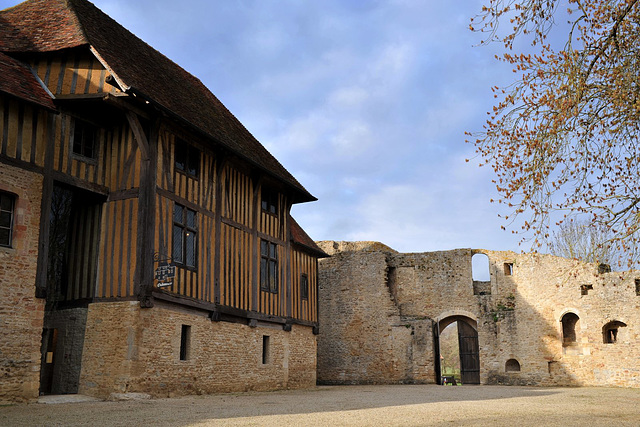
xmin=40 ymin=183 xmax=104 ymax=394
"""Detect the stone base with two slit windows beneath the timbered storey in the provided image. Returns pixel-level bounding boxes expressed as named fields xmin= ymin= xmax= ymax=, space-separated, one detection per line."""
xmin=80 ymin=302 xmax=317 ymax=397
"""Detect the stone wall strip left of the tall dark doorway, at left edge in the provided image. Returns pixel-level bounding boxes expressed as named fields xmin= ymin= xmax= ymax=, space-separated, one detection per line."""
xmin=0 ymin=164 xmax=44 ymax=401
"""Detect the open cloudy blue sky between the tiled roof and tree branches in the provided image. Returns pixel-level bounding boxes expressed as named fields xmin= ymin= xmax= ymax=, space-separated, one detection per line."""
xmin=0 ymin=0 xmax=529 ymax=252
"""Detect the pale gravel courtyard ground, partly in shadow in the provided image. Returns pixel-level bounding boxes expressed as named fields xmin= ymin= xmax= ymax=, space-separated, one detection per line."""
xmin=0 ymin=385 xmax=640 ymax=427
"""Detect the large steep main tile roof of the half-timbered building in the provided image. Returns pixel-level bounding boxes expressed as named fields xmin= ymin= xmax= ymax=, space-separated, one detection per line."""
xmin=0 ymin=0 xmax=316 ymax=202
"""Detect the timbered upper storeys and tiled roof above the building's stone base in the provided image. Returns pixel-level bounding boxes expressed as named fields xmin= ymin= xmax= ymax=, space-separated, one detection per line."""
xmin=0 ymin=0 xmax=325 ymax=332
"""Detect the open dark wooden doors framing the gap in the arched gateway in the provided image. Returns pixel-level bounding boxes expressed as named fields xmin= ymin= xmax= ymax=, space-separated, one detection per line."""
xmin=433 ymin=315 xmax=480 ymax=384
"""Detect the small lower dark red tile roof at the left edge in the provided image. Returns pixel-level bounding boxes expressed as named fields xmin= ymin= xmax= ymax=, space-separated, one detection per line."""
xmin=0 ymin=53 xmax=56 ymax=110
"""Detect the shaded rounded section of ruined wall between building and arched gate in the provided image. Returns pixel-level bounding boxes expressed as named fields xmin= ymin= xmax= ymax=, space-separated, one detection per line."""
xmin=318 ymin=244 xmax=424 ymax=384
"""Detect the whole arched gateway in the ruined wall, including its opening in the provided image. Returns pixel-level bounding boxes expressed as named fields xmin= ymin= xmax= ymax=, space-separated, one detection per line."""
xmin=434 ymin=316 xmax=480 ymax=384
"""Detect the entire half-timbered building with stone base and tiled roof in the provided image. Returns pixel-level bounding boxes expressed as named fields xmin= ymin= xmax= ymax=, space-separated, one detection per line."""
xmin=0 ymin=0 xmax=324 ymax=400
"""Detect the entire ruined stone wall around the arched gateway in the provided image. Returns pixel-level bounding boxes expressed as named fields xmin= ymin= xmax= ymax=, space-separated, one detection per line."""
xmin=318 ymin=242 xmax=640 ymax=387
